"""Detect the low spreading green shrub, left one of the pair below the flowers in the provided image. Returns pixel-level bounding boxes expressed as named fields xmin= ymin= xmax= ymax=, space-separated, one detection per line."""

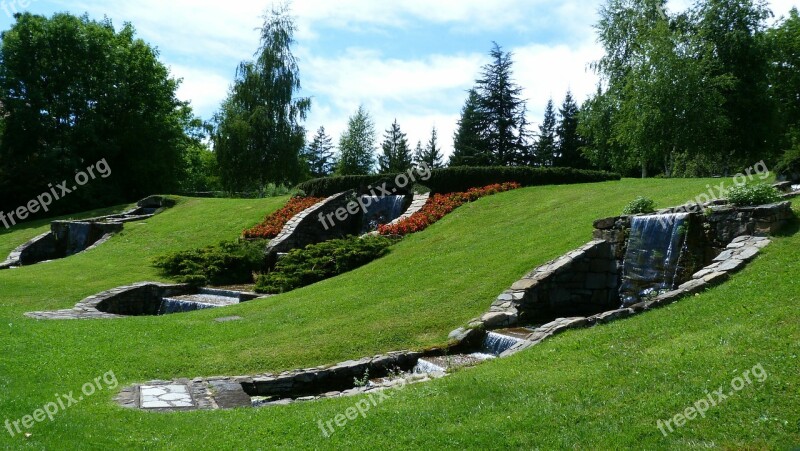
xmin=153 ymin=240 xmax=267 ymax=286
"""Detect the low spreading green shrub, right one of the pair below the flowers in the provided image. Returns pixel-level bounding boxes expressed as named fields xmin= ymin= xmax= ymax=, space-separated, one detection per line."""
xmin=256 ymin=236 xmax=393 ymax=294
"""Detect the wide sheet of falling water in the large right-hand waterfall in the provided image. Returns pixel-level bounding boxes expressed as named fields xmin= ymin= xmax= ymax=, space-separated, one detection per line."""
xmin=620 ymin=213 xmax=689 ymax=305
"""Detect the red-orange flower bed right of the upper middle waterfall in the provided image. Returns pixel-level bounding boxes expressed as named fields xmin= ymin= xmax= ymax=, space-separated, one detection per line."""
xmin=378 ymin=182 xmax=521 ymax=236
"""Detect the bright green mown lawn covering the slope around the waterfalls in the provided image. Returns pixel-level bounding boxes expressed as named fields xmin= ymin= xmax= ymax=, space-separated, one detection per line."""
xmin=0 ymin=180 xmax=800 ymax=449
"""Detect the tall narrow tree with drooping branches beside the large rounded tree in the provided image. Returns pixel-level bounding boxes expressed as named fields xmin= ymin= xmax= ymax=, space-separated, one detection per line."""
xmin=214 ymin=6 xmax=311 ymax=191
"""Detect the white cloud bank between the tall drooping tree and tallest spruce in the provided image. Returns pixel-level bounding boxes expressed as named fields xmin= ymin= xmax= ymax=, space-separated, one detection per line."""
xmin=302 ymin=49 xmax=485 ymax=158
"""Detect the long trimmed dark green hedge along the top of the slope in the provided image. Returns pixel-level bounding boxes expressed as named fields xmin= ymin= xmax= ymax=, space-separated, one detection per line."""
xmin=297 ymin=167 xmax=622 ymax=197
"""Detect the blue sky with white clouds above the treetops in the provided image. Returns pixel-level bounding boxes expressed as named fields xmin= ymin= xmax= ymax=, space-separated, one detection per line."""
xmin=0 ymin=0 xmax=796 ymax=158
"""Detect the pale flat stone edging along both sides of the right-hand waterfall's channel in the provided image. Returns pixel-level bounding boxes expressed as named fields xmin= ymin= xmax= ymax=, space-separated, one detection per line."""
xmin=450 ymin=236 xmax=771 ymax=357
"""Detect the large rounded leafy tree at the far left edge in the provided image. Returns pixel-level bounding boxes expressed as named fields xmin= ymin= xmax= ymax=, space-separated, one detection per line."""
xmin=0 ymin=13 xmax=191 ymax=214
